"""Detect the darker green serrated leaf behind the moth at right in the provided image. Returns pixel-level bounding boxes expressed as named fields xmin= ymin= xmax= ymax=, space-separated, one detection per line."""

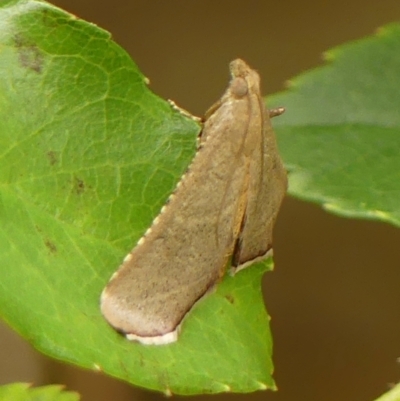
xmin=269 ymin=24 xmax=400 ymax=226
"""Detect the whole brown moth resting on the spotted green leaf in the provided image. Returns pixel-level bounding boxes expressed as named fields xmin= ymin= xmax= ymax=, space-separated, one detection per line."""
xmin=101 ymin=59 xmax=287 ymax=344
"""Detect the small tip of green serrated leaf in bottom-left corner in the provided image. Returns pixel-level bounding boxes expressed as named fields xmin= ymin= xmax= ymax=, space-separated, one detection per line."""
xmin=0 ymin=383 xmax=80 ymax=401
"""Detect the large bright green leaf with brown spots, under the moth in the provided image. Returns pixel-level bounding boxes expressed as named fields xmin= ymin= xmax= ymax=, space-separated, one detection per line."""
xmin=0 ymin=0 xmax=274 ymax=394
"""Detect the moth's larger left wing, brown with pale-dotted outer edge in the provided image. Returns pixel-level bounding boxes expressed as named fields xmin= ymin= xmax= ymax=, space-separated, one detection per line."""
xmin=101 ymin=93 xmax=248 ymax=343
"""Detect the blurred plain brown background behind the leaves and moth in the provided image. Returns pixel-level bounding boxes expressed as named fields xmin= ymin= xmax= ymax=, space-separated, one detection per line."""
xmin=0 ymin=0 xmax=400 ymax=401
